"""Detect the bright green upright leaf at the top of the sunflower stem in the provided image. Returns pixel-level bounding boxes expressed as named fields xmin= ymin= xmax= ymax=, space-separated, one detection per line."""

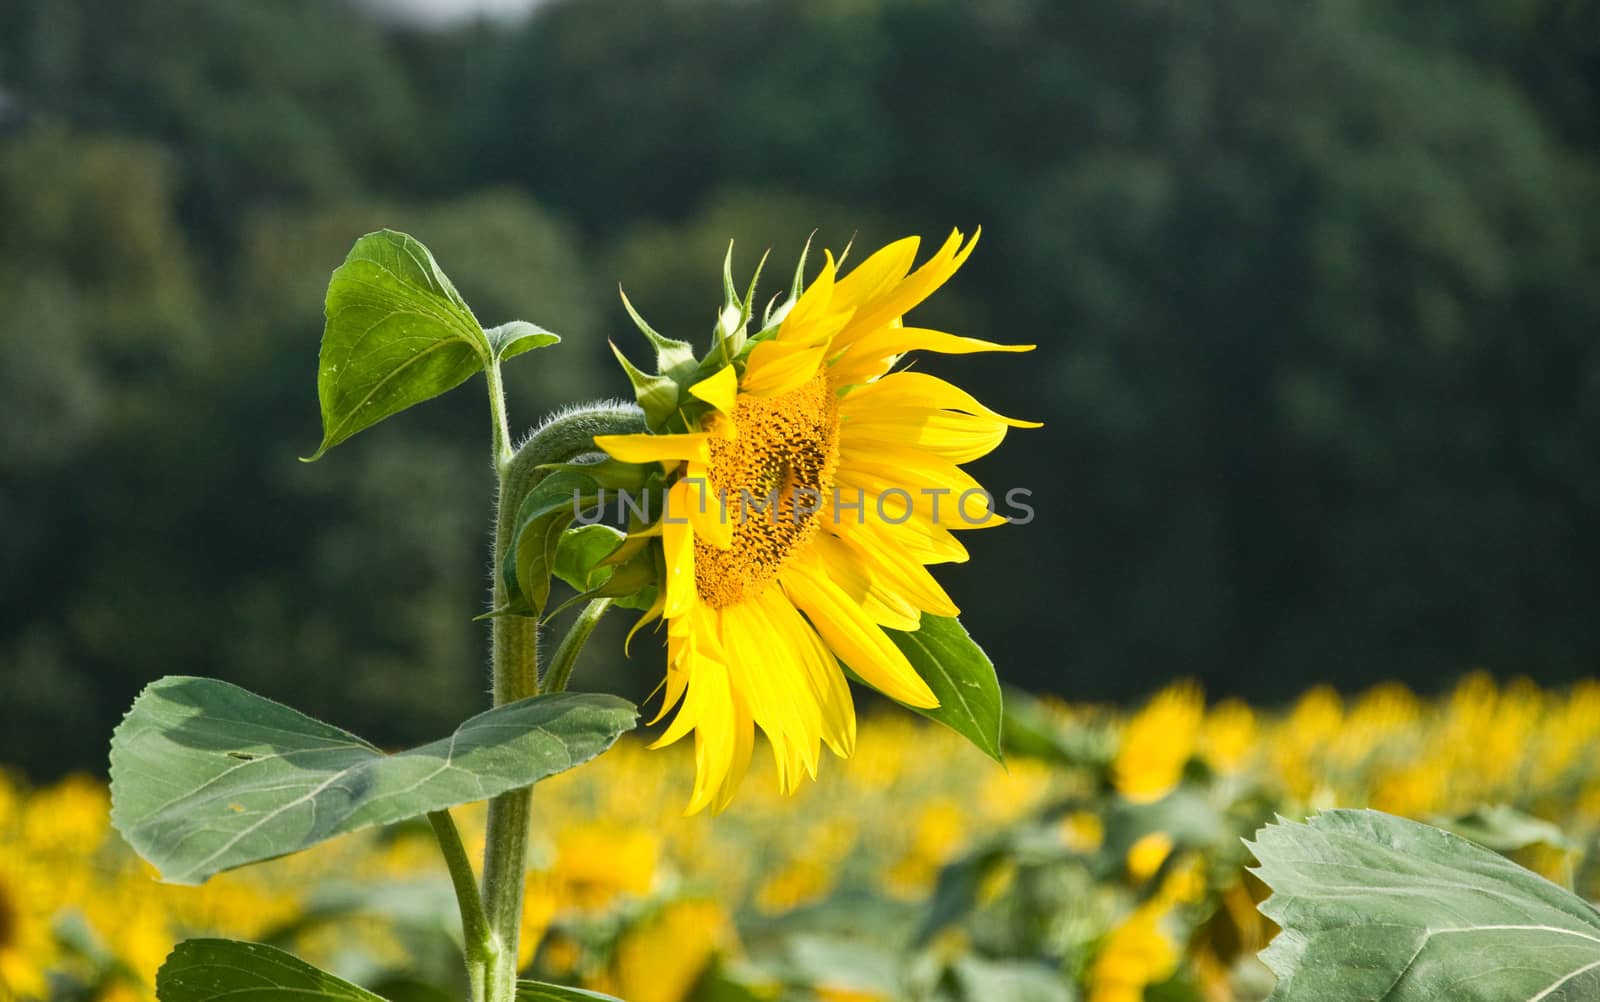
xmin=307 ymin=229 xmax=486 ymax=461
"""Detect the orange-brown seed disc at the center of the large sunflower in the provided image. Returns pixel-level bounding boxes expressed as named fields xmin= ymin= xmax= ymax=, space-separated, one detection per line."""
xmin=694 ymin=366 xmax=838 ymax=608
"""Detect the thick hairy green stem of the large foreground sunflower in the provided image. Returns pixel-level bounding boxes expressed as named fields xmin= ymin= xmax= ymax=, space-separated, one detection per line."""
xmin=469 ymin=392 xmax=645 ymax=1002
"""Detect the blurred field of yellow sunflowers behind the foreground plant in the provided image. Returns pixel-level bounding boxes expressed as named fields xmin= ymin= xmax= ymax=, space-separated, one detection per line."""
xmin=12 ymin=675 xmax=1600 ymax=1002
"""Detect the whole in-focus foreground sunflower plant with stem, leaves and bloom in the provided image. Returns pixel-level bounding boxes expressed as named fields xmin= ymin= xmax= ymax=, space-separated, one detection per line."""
xmin=110 ymin=230 xmax=1026 ymax=1002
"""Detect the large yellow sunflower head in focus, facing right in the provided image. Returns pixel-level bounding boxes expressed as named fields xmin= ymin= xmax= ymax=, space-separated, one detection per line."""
xmin=595 ymin=232 xmax=1037 ymax=813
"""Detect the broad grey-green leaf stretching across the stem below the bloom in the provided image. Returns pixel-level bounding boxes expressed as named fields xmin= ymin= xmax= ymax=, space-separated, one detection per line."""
xmin=110 ymin=675 xmax=637 ymax=884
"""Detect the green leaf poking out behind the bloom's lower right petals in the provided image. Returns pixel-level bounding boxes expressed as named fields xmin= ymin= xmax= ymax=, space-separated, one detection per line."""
xmin=883 ymin=613 xmax=1005 ymax=764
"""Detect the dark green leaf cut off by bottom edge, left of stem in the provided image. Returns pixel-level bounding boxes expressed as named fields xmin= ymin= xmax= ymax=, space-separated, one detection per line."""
xmin=155 ymin=940 xmax=384 ymax=1002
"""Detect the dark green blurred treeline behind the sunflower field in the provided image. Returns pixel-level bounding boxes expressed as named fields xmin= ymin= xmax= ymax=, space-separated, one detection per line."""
xmin=0 ymin=0 xmax=1600 ymax=775
